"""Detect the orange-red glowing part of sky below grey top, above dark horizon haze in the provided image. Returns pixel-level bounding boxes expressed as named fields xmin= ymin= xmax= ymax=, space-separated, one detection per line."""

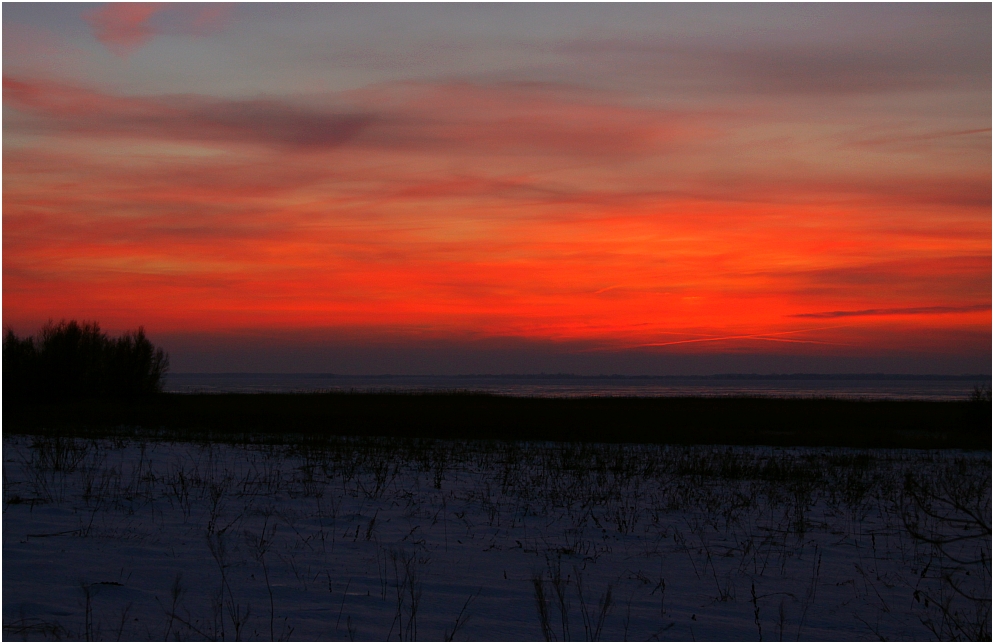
xmin=3 ymin=7 xmax=991 ymax=371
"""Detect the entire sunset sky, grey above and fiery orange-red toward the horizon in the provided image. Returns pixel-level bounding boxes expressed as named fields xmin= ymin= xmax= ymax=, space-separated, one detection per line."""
xmin=2 ymin=3 xmax=992 ymax=375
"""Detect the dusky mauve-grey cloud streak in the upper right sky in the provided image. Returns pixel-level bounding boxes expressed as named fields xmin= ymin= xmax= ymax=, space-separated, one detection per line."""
xmin=556 ymin=30 xmax=991 ymax=97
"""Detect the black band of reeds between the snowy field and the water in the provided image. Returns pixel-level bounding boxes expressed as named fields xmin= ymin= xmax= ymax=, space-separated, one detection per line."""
xmin=3 ymin=393 xmax=991 ymax=450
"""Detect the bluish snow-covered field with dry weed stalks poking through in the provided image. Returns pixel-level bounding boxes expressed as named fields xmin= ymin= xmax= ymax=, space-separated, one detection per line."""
xmin=3 ymin=436 xmax=991 ymax=640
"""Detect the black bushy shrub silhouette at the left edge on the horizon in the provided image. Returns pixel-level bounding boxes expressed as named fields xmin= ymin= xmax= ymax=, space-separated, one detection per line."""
xmin=3 ymin=320 xmax=169 ymax=400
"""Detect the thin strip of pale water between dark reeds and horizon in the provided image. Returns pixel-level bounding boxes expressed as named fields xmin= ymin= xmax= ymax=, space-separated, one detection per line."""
xmin=165 ymin=373 xmax=991 ymax=400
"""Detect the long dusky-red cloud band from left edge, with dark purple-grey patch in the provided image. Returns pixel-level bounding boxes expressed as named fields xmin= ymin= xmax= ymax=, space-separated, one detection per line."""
xmin=4 ymin=76 xmax=696 ymax=156
